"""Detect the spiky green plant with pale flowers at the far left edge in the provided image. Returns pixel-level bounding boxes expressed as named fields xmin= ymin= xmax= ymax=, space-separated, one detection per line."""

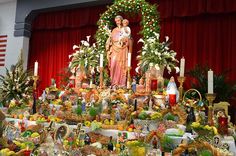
xmin=0 ymin=53 xmax=33 ymax=105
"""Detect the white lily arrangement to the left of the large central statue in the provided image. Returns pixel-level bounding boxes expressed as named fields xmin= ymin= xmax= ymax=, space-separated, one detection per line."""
xmin=69 ymin=36 xmax=99 ymax=73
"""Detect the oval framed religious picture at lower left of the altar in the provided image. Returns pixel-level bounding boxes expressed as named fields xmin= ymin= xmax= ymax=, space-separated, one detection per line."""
xmin=54 ymin=124 xmax=70 ymax=140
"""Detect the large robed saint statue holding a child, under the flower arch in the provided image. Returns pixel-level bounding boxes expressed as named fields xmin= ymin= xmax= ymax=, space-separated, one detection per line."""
xmin=106 ymin=15 xmax=132 ymax=87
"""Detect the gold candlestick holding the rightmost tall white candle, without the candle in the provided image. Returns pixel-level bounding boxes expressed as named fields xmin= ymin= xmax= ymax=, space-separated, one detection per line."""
xmin=206 ymin=93 xmax=216 ymax=126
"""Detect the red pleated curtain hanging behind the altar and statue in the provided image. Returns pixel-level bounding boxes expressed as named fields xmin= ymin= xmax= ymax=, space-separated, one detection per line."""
xmin=28 ymin=0 xmax=236 ymax=95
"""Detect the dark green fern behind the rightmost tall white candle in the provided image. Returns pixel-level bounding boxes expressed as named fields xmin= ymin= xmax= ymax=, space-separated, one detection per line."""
xmin=187 ymin=65 xmax=236 ymax=102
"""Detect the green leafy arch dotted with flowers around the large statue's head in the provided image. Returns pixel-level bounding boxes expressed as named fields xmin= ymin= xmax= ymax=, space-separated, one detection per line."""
xmin=96 ymin=0 xmax=160 ymax=64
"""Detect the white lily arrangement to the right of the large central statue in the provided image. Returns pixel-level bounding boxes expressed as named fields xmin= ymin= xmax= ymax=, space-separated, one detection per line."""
xmin=137 ymin=33 xmax=179 ymax=73
